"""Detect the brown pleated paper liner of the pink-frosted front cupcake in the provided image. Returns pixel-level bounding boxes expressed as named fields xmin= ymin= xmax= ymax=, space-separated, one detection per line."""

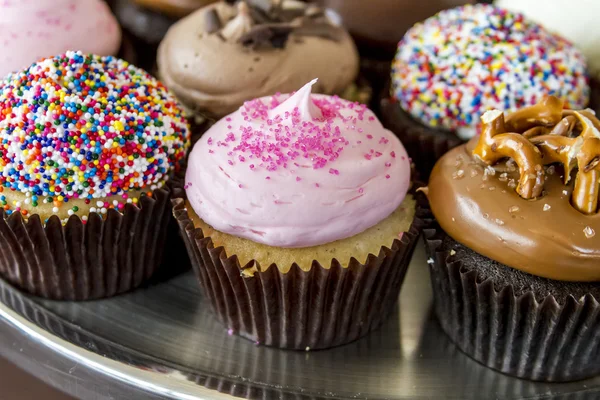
xmin=173 ymin=192 xmax=424 ymax=350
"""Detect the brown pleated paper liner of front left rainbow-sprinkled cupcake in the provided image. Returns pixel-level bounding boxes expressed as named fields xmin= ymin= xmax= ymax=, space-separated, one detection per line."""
xmin=0 ymin=188 xmax=171 ymax=300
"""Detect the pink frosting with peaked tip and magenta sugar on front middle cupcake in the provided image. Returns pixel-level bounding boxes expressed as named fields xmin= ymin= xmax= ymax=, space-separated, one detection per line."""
xmin=186 ymin=80 xmax=410 ymax=247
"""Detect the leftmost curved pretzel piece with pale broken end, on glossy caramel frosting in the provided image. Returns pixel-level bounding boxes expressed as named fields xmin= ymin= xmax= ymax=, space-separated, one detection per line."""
xmin=473 ymin=110 xmax=548 ymax=199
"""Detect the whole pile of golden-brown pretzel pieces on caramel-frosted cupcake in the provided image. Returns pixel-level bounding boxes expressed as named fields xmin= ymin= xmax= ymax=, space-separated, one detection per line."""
xmin=473 ymin=96 xmax=600 ymax=214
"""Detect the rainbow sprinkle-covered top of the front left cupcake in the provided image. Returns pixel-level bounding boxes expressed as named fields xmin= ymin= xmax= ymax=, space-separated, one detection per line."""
xmin=0 ymin=52 xmax=190 ymax=214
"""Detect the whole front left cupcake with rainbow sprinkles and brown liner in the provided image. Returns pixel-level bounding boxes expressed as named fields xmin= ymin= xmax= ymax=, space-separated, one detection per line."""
xmin=0 ymin=52 xmax=189 ymax=300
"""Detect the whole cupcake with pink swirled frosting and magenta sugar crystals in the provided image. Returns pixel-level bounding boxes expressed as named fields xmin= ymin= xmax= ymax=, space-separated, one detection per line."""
xmin=174 ymin=80 xmax=421 ymax=350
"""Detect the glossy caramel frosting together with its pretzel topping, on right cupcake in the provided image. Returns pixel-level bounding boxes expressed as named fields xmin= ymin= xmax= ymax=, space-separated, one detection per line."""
xmin=427 ymin=97 xmax=600 ymax=282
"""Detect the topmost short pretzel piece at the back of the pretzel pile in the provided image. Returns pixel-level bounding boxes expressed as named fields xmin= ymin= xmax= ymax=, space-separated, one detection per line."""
xmin=506 ymin=96 xmax=564 ymax=132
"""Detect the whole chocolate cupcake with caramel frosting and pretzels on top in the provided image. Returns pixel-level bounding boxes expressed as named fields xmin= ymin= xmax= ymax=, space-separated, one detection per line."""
xmin=425 ymin=96 xmax=600 ymax=381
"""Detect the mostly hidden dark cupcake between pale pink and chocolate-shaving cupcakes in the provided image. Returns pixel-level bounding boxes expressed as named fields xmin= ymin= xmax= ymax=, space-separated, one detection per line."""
xmin=111 ymin=0 xmax=215 ymax=71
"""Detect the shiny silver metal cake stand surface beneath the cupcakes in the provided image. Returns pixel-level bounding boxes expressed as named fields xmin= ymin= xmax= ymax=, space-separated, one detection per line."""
xmin=0 ymin=248 xmax=600 ymax=400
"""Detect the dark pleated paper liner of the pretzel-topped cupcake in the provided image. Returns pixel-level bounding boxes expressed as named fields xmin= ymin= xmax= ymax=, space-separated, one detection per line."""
xmin=424 ymin=225 xmax=600 ymax=382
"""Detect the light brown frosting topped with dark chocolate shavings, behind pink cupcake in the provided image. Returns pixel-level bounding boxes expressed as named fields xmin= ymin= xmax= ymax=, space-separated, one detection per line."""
xmin=158 ymin=0 xmax=359 ymax=118
